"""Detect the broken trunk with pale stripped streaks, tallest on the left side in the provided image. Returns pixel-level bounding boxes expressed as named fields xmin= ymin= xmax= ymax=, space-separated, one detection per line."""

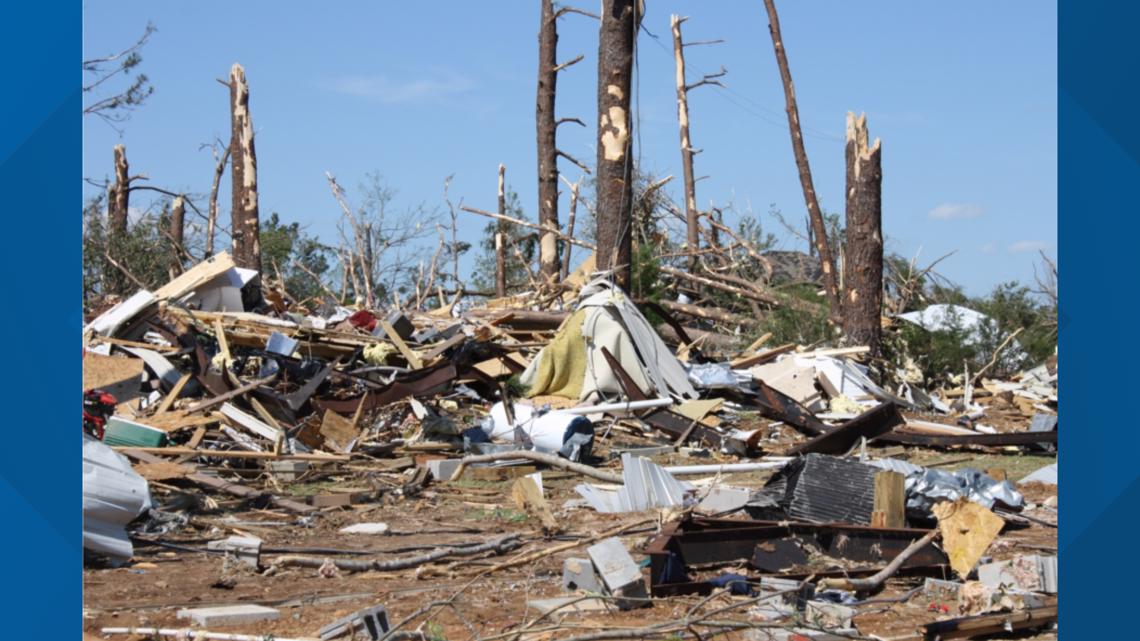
xmin=229 ymin=64 xmax=261 ymax=298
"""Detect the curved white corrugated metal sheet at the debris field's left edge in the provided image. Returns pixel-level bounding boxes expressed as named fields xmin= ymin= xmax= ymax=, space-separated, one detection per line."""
xmin=83 ymin=435 xmax=150 ymax=560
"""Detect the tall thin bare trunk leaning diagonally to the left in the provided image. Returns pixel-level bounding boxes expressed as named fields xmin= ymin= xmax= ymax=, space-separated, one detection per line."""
xmin=764 ymin=0 xmax=842 ymax=324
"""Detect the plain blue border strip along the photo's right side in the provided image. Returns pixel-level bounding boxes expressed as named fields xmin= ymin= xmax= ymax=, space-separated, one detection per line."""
xmin=1058 ymin=0 xmax=1140 ymax=639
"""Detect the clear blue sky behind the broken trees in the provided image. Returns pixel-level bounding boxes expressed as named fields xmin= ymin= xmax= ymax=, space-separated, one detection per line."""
xmin=83 ymin=0 xmax=1057 ymax=294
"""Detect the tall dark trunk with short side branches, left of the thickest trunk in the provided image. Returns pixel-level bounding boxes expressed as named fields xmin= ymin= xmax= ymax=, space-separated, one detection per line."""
xmin=535 ymin=0 xmax=560 ymax=286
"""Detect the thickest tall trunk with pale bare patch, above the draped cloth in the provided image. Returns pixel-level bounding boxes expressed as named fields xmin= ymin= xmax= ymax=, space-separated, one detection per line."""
xmin=595 ymin=0 xmax=641 ymax=291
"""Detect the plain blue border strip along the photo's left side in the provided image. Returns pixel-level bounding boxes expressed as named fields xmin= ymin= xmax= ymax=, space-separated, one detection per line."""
xmin=0 ymin=1 xmax=82 ymax=639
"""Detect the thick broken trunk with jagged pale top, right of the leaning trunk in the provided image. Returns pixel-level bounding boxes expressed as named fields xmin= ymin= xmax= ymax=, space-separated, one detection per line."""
xmin=844 ymin=112 xmax=882 ymax=357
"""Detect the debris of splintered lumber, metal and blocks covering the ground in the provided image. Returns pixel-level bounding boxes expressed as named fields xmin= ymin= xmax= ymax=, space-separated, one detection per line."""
xmin=83 ymin=253 xmax=1057 ymax=640
